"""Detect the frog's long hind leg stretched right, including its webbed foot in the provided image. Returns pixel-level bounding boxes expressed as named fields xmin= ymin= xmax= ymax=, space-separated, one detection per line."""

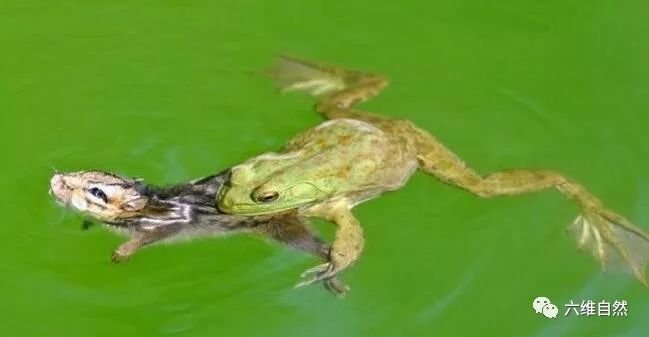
xmin=412 ymin=127 xmax=649 ymax=286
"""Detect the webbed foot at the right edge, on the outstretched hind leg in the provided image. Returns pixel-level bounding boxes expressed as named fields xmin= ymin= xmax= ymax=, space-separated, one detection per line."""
xmin=568 ymin=208 xmax=649 ymax=287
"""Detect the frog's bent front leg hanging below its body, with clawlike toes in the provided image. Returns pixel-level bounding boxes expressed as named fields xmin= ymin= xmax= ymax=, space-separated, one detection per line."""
xmin=296 ymin=200 xmax=365 ymax=287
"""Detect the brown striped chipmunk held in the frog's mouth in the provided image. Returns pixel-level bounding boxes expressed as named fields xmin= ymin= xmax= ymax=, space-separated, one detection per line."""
xmin=50 ymin=170 xmax=349 ymax=296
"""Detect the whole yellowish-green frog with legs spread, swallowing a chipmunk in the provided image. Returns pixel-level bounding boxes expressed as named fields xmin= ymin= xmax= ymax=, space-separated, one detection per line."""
xmin=219 ymin=58 xmax=649 ymax=285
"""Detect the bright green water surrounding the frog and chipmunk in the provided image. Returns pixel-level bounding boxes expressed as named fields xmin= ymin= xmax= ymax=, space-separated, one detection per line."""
xmin=0 ymin=0 xmax=649 ymax=337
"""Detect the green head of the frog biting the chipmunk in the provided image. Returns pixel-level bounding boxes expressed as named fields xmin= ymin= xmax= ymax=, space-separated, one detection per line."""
xmin=218 ymin=159 xmax=328 ymax=215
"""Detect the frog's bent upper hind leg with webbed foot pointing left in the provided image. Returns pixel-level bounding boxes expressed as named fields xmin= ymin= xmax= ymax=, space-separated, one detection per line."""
xmin=268 ymin=56 xmax=388 ymax=120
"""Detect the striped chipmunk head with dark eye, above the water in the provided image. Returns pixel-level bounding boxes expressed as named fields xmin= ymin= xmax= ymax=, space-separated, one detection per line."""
xmin=50 ymin=171 xmax=149 ymax=222
